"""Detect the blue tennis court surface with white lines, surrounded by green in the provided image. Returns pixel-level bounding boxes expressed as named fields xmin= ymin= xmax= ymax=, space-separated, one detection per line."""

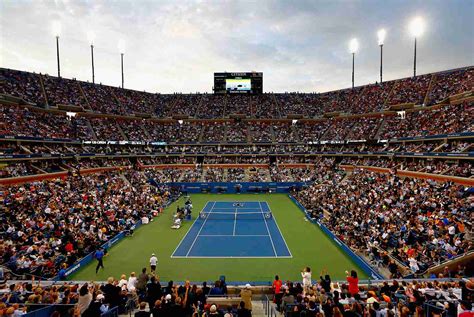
xmin=171 ymin=201 xmax=292 ymax=258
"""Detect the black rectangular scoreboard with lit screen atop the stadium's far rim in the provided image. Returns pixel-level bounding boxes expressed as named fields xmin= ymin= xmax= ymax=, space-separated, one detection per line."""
xmin=214 ymin=72 xmax=263 ymax=94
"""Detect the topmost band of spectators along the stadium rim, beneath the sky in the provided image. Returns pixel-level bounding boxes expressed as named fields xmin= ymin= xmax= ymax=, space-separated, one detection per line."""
xmin=0 ymin=67 xmax=473 ymax=119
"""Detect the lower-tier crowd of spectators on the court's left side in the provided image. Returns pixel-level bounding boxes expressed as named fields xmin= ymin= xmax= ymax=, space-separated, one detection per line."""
xmin=0 ymin=171 xmax=170 ymax=278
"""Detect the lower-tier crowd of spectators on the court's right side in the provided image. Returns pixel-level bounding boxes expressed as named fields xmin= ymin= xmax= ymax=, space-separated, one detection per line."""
xmin=297 ymin=169 xmax=474 ymax=276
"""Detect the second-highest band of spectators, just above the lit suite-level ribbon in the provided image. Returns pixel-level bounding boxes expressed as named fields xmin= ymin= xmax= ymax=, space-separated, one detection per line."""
xmin=0 ymin=102 xmax=474 ymax=146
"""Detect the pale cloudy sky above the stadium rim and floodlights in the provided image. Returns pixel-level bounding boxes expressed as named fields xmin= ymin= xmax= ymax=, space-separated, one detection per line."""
xmin=0 ymin=0 xmax=474 ymax=93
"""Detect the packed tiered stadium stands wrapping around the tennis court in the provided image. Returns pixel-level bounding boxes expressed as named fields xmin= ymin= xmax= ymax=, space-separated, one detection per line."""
xmin=0 ymin=67 xmax=474 ymax=316
